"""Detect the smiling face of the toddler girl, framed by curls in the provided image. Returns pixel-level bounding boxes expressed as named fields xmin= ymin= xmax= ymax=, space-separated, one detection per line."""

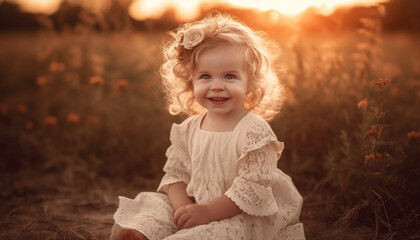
xmin=192 ymin=46 xmax=248 ymax=116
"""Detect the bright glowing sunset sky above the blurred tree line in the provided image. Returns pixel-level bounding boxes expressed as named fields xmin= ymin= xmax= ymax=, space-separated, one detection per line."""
xmin=8 ymin=0 xmax=386 ymax=20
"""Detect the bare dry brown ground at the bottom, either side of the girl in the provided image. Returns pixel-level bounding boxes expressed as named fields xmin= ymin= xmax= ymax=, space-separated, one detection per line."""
xmin=0 ymin=171 xmax=373 ymax=240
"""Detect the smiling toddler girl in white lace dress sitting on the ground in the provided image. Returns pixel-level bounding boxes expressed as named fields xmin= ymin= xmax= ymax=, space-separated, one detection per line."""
xmin=111 ymin=14 xmax=305 ymax=240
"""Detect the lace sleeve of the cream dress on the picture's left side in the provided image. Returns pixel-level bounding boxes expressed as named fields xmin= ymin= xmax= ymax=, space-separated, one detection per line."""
xmin=157 ymin=124 xmax=191 ymax=193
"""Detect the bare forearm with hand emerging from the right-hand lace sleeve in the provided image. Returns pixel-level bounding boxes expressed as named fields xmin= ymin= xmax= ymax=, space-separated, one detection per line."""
xmin=174 ymin=195 xmax=242 ymax=229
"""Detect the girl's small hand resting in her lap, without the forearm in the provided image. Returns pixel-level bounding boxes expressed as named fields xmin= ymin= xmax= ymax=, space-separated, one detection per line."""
xmin=174 ymin=204 xmax=211 ymax=229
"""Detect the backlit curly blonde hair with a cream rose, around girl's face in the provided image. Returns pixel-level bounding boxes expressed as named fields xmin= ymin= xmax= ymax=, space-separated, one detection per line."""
xmin=160 ymin=12 xmax=283 ymax=121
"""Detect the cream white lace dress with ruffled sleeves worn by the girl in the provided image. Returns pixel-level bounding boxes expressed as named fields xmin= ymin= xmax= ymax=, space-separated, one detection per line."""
xmin=111 ymin=113 xmax=305 ymax=240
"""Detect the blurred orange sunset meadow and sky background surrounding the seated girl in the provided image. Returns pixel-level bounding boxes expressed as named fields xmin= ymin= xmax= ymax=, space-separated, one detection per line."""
xmin=0 ymin=0 xmax=420 ymax=239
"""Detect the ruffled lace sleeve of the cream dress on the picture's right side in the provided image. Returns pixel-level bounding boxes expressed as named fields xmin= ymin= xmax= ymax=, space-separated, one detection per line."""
xmin=225 ymin=119 xmax=284 ymax=216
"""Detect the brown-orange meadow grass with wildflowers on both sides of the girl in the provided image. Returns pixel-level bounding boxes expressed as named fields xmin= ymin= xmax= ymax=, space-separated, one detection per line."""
xmin=0 ymin=20 xmax=420 ymax=239
